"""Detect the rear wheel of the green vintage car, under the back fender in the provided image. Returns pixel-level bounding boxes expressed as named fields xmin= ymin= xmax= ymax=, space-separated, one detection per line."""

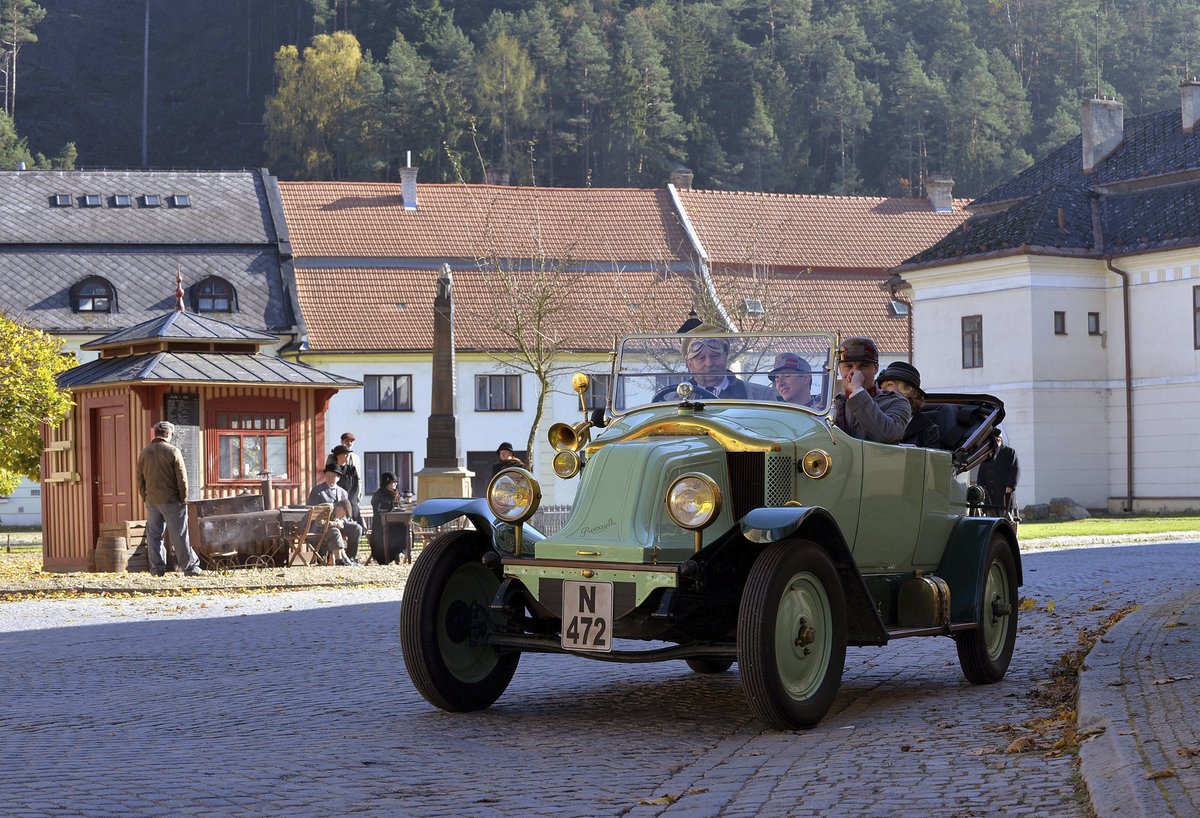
xmin=954 ymin=534 xmax=1018 ymax=685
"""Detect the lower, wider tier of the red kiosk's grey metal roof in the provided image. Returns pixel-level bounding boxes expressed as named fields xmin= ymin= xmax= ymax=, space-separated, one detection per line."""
xmin=58 ymin=351 xmax=361 ymax=389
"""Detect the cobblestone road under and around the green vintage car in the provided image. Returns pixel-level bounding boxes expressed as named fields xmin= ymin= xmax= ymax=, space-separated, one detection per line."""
xmin=0 ymin=543 xmax=1200 ymax=818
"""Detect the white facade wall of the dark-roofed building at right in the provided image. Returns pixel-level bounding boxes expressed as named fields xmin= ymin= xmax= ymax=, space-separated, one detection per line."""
xmin=905 ymin=252 xmax=1200 ymax=511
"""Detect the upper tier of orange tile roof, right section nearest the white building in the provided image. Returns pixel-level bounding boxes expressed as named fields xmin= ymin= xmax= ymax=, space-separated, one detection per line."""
xmin=679 ymin=190 xmax=970 ymax=271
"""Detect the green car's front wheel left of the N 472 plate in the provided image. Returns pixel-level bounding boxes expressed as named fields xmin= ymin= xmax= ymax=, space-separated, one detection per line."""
xmin=400 ymin=531 xmax=521 ymax=711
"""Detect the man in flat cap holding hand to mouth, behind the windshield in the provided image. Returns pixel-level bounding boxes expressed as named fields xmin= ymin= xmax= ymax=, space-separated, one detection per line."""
xmin=834 ymin=337 xmax=912 ymax=443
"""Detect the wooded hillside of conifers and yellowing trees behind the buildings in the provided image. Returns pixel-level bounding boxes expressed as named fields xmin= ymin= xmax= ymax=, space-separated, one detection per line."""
xmin=9 ymin=0 xmax=1200 ymax=196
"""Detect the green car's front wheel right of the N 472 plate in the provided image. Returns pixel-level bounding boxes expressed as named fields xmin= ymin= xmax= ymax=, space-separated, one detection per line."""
xmin=738 ymin=540 xmax=846 ymax=729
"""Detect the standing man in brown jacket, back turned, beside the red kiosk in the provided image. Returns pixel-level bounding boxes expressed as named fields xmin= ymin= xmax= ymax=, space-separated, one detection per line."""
xmin=138 ymin=420 xmax=204 ymax=577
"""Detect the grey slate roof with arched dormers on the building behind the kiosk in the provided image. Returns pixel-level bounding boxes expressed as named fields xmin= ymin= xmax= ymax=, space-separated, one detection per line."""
xmin=0 ymin=170 xmax=295 ymax=335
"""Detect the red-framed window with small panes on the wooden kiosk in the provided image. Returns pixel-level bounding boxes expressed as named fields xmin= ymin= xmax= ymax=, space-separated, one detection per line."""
xmin=211 ymin=411 xmax=292 ymax=482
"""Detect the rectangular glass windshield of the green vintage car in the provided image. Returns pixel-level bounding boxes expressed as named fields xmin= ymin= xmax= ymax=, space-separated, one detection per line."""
xmin=610 ymin=332 xmax=836 ymax=414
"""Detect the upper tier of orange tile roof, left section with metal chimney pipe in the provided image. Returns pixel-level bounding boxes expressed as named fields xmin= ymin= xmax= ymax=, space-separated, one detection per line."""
xmin=280 ymin=181 xmax=691 ymax=263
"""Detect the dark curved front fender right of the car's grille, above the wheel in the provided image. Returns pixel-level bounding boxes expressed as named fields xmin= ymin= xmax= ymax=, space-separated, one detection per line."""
xmin=740 ymin=506 xmax=888 ymax=645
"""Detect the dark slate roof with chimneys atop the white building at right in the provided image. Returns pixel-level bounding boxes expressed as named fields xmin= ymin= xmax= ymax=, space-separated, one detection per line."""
xmin=900 ymin=108 xmax=1200 ymax=270
